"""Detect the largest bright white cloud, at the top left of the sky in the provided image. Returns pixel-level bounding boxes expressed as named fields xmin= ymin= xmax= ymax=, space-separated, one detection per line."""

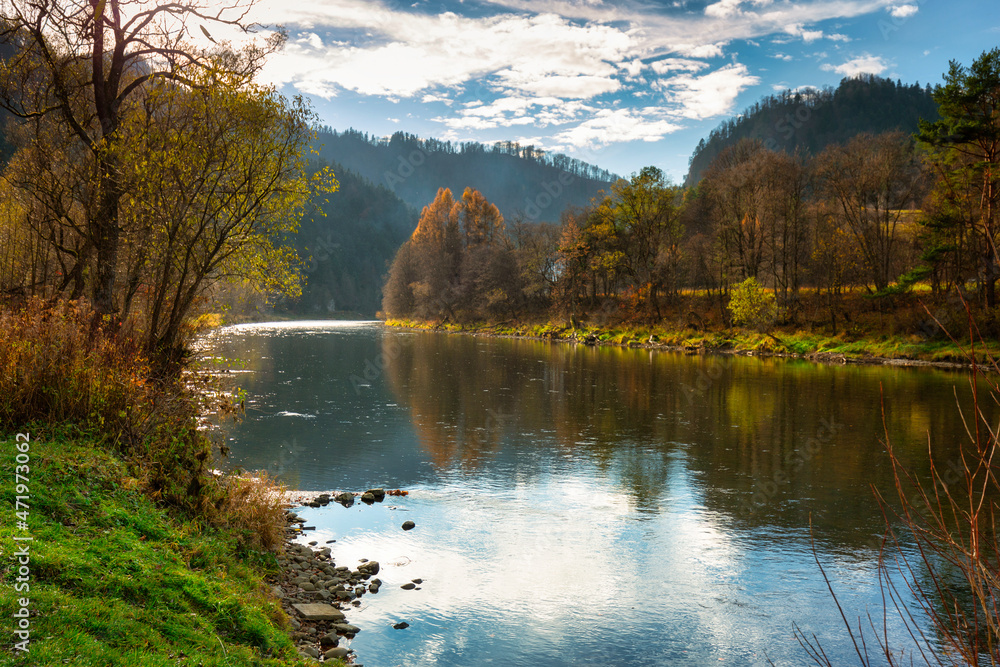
xmin=258 ymin=0 xmax=636 ymax=97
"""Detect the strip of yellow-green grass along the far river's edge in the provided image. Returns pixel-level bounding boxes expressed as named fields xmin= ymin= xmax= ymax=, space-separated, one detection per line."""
xmin=386 ymin=320 xmax=1000 ymax=363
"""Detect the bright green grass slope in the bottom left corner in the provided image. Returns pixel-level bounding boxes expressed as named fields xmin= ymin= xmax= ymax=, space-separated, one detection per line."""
xmin=0 ymin=431 xmax=315 ymax=667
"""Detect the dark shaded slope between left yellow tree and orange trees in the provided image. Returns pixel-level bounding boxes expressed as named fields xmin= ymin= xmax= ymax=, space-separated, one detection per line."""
xmin=292 ymin=161 xmax=418 ymax=316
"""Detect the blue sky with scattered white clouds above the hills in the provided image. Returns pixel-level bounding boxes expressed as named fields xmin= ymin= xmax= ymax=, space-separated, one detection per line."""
xmin=250 ymin=0 xmax=1000 ymax=181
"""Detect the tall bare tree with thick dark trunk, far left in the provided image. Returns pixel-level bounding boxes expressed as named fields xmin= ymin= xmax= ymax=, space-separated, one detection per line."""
xmin=0 ymin=0 xmax=283 ymax=314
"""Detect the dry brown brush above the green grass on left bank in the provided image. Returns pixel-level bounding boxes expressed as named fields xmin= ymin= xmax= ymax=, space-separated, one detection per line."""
xmin=0 ymin=299 xmax=258 ymax=528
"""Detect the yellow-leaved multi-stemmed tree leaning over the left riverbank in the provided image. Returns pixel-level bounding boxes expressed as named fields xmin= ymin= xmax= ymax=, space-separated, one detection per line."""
xmin=119 ymin=82 xmax=328 ymax=358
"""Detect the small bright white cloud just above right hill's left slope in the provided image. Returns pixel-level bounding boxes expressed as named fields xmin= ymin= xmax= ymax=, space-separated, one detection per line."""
xmin=658 ymin=63 xmax=760 ymax=120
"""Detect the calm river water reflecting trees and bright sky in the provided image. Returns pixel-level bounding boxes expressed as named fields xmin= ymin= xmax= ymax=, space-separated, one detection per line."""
xmin=206 ymin=322 xmax=984 ymax=667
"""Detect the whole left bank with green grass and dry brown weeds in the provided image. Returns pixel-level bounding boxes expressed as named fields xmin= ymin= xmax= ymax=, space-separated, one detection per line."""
xmin=0 ymin=300 xmax=344 ymax=667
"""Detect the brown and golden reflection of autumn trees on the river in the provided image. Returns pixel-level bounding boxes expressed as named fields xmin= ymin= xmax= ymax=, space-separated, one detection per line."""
xmin=382 ymin=333 xmax=984 ymax=550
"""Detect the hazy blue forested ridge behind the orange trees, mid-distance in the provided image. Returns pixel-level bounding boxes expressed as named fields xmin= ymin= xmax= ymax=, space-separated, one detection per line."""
xmin=317 ymin=128 xmax=617 ymax=222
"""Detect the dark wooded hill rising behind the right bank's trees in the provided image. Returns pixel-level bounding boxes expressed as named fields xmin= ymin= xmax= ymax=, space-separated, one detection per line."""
xmin=685 ymin=74 xmax=938 ymax=186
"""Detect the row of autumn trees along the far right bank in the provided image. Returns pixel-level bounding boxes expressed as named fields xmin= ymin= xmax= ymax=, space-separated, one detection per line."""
xmin=383 ymin=49 xmax=1000 ymax=328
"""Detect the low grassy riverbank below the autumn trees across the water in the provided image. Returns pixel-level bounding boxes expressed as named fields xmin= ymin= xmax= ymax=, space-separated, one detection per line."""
xmin=385 ymin=319 xmax=1000 ymax=368
